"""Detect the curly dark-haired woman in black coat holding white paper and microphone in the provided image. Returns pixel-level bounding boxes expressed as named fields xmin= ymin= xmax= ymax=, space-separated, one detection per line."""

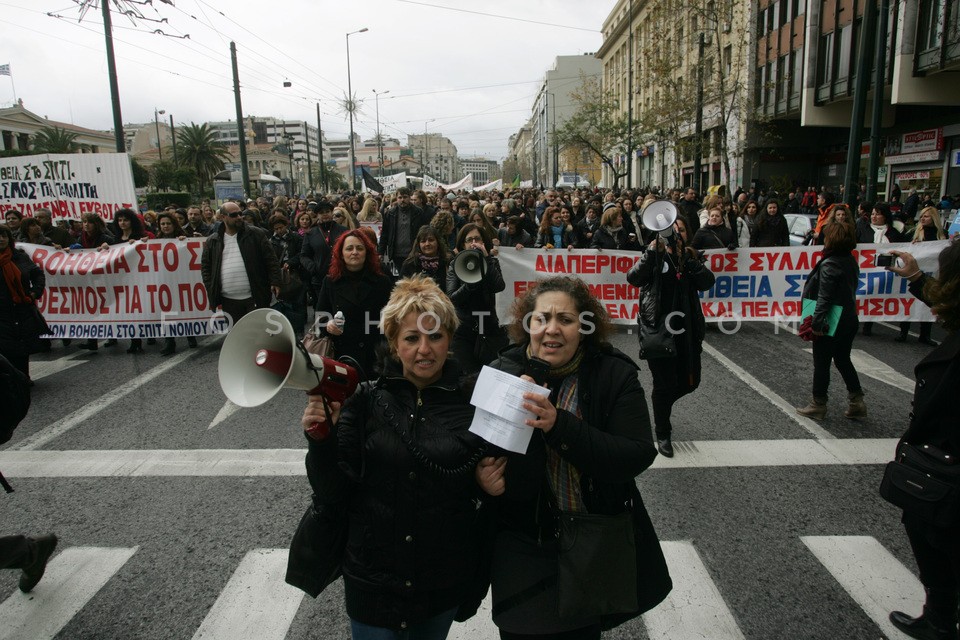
xmin=477 ymin=277 xmax=671 ymax=639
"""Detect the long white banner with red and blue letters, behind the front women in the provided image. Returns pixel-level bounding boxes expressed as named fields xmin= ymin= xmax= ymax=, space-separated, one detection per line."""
xmin=497 ymin=241 xmax=947 ymax=324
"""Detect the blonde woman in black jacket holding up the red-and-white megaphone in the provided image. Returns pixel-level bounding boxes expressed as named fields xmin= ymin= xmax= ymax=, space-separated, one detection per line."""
xmin=287 ymin=276 xmax=487 ymax=640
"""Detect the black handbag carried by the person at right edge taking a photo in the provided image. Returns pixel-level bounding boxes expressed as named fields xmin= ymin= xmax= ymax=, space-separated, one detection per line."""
xmin=880 ymin=442 xmax=960 ymax=527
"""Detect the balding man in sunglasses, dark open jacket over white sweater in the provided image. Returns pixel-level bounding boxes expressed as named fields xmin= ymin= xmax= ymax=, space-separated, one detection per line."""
xmin=201 ymin=202 xmax=281 ymax=323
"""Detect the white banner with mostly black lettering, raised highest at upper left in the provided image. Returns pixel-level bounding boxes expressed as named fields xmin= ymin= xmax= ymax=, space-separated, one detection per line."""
xmin=0 ymin=153 xmax=137 ymax=221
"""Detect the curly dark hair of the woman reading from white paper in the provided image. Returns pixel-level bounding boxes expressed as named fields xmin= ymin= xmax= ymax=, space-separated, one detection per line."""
xmin=507 ymin=276 xmax=610 ymax=350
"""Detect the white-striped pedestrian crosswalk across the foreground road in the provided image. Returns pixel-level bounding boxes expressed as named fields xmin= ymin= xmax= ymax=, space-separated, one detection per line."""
xmin=0 ymin=536 xmax=923 ymax=640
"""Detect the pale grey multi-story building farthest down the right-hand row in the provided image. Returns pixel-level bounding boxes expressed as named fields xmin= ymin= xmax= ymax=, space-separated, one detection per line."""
xmin=530 ymin=53 xmax=603 ymax=186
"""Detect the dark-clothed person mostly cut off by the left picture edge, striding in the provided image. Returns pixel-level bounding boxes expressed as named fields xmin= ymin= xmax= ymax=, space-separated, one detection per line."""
xmin=0 ymin=356 xmax=57 ymax=593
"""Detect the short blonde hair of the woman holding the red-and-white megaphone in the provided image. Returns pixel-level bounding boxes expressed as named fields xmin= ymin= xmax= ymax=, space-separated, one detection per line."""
xmin=380 ymin=274 xmax=460 ymax=355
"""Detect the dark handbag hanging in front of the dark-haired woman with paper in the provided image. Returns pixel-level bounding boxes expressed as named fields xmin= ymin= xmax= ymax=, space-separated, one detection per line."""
xmin=557 ymin=511 xmax=639 ymax=618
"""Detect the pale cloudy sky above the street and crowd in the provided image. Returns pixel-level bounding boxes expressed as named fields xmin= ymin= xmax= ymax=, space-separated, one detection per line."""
xmin=0 ymin=0 xmax=615 ymax=160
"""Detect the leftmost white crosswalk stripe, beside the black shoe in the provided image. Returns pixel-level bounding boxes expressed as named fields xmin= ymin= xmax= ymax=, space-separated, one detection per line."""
xmin=0 ymin=547 xmax=138 ymax=640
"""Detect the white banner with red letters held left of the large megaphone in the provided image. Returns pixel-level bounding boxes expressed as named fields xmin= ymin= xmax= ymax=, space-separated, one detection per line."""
xmin=17 ymin=238 xmax=230 ymax=339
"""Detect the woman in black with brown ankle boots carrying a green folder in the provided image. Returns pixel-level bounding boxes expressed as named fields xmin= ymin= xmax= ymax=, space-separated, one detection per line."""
xmin=797 ymin=222 xmax=867 ymax=420
